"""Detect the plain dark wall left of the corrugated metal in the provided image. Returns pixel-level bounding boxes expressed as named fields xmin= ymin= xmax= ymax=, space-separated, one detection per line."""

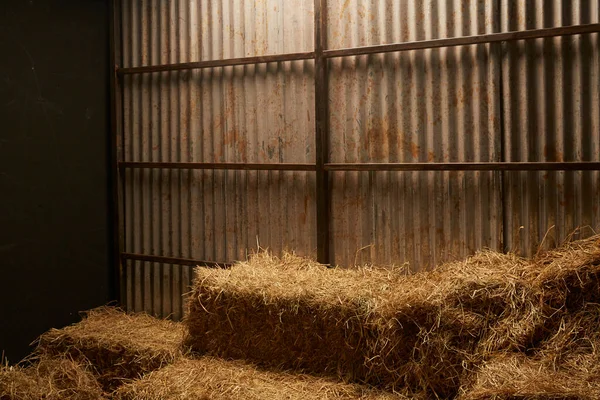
xmin=0 ymin=0 xmax=113 ymax=362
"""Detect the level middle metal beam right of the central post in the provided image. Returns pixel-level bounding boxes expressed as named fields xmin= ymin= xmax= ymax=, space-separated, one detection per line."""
xmin=325 ymin=162 xmax=600 ymax=171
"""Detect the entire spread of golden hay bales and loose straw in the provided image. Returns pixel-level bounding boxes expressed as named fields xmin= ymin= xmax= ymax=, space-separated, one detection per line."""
xmin=0 ymin=237 xmax=600 ymax=400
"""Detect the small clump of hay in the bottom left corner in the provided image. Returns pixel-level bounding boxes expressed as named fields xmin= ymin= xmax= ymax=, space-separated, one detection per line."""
xmin=0 ymin=358 xmax=105 ymax=400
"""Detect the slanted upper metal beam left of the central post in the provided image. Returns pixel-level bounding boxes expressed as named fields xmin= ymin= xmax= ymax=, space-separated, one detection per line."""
xmin=117 ymin=51 xmax=315 ymax=75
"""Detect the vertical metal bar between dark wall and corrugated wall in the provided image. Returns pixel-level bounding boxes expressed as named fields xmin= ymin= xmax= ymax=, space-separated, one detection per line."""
xmin=109 ymin=0 xmax=127 ymax=305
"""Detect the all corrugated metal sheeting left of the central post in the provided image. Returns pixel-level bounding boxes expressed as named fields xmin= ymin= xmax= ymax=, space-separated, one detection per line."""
xmin=122 ymin=0 xmax=316 ymax=318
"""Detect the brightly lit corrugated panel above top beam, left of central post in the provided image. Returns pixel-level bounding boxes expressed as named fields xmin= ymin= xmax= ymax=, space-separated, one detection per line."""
xmin=122 ymin=0 xmax=314 ymax=68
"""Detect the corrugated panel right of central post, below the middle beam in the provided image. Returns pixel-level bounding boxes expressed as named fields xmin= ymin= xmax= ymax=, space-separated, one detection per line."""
xmin=332 ymin=172 xmax=502 ymax=270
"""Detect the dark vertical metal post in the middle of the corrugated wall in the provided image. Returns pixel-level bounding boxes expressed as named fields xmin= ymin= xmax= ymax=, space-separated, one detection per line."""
xmin=314 ymin=0 xmax=331 ymax=264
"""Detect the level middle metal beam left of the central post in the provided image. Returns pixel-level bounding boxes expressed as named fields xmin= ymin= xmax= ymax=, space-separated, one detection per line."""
xmin=119 ymin=161 xmax=317 ymax=171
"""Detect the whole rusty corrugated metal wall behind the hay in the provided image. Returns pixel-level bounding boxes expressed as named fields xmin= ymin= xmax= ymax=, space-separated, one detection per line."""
xmin=121 ymin=0 xmax=600 ymax=318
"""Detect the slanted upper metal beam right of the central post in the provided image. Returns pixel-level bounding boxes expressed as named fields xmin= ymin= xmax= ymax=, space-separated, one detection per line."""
xmin=324 ymin=24 xmax=600 ymax=58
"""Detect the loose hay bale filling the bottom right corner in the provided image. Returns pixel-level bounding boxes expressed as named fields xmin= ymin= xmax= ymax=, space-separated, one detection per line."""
xmin=459 ymin=303 xmax=600 ymax=400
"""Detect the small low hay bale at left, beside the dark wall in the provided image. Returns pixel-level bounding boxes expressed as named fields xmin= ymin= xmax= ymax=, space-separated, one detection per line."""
xmin=36 ymin=307 xmax=184 ymax=390
